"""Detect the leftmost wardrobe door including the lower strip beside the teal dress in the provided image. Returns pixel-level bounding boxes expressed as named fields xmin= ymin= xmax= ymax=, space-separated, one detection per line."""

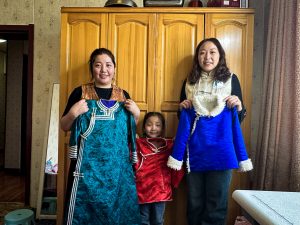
xmin=57 ymin=13 xmax=108 ymax=224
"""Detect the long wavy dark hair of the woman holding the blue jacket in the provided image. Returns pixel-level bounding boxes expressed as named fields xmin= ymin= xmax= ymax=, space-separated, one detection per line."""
xmin=188 ymin=38 xmax=231 ymax=84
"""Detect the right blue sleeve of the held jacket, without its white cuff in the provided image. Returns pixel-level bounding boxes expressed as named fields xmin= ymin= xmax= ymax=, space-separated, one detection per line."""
xmin=232 ymin=107 xmax=248 ymax=162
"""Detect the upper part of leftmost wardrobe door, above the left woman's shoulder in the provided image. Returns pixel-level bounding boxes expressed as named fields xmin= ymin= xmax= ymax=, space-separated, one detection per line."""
xmin=61 ymin=13 xmax=107 ymax=102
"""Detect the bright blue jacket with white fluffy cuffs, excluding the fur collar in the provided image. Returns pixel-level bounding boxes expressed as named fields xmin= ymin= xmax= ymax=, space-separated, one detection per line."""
xmin=168 ymin=107 xmax=252 ymax=172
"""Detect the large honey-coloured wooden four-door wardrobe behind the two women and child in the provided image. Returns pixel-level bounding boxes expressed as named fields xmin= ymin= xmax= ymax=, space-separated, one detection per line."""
xmin=57 ymin=7 xmax=254 ymax=225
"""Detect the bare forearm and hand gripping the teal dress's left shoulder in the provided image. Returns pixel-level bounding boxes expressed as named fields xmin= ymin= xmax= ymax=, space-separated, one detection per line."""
xmin=60 ymin=99 xmax=89 ymax=131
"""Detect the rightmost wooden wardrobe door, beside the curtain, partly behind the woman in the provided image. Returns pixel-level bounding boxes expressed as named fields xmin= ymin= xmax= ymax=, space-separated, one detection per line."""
xmin=205 ymin=14 xmax=254 ymax=224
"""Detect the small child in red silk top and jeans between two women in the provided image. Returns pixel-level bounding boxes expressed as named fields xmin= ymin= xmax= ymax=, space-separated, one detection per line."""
xmin=136 ymin=112 xmax=184 ymax=225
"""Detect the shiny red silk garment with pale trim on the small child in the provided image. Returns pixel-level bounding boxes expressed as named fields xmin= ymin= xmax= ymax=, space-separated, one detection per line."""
xmin=135 ymin=138 xmax=184 ymax=204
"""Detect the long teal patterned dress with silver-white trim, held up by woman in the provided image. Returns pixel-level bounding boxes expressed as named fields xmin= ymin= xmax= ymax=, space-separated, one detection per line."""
xmin=66 ymin=100 xmax=140 ymax=225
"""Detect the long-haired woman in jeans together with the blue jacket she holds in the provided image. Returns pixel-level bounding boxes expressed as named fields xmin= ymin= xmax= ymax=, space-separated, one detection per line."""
xmin=168 ymin=38 xmax=253 ymax=225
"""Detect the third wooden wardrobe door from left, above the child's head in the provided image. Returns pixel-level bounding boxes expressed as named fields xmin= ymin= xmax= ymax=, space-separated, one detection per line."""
xmin=154 ymin=13 xmax=204 ymax=139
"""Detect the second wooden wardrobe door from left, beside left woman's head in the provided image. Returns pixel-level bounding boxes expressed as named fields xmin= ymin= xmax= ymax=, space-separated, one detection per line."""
xmin=108 ymin=13 xmax=156 ymax=135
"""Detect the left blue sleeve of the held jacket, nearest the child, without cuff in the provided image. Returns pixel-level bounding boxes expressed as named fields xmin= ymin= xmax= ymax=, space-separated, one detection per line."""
xmin=171 ymin=109 xmax=195 ymax=161
